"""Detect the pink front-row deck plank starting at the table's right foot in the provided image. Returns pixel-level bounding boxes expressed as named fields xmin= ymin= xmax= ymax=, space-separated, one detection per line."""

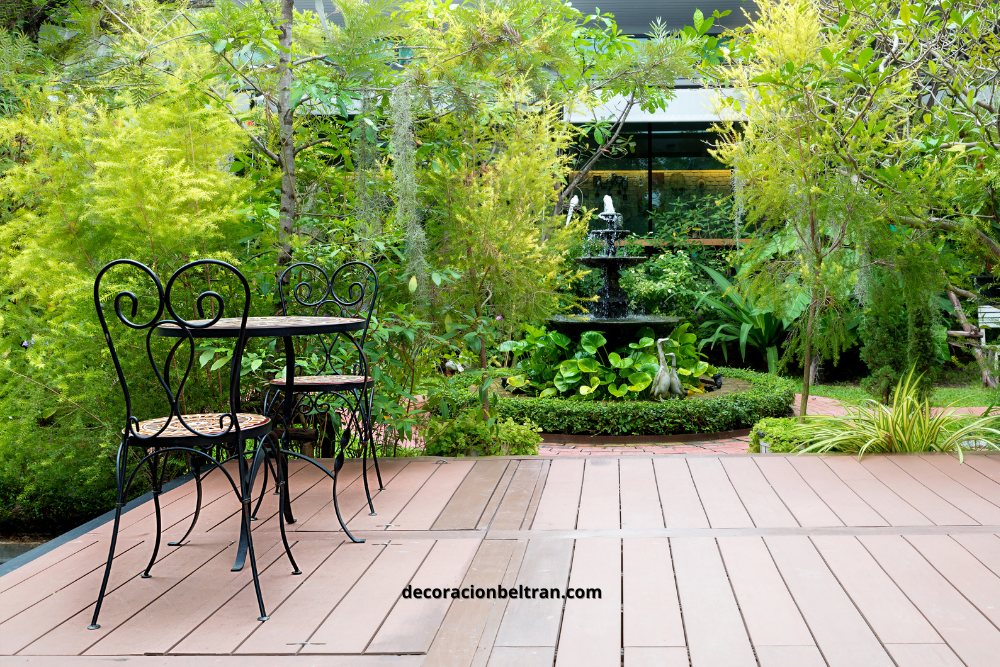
xmin=236 ymin=538 xmax=388 ymax=657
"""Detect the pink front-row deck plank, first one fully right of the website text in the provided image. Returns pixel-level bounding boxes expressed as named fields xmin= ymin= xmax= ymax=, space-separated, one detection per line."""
xmin=622 ymin=537 xmax=687 ymax=662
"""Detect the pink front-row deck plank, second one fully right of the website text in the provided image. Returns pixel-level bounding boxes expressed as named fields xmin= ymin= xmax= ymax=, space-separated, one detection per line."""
xmin=670 ymin=537 xmax=757 ymax=667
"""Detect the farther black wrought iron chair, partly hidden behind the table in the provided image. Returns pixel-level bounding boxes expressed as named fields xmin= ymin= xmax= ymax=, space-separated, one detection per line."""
xmin=255 ymin=262 xmax=385 ymax=524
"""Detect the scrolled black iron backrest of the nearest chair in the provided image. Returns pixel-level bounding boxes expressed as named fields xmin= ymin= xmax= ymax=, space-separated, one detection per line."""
xmin=94 ymin=259 xmax=250 ymax=440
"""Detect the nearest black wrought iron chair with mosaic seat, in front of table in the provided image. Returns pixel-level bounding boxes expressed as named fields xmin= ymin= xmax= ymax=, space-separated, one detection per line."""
xmin=89 ymin=259 xmax=298 ymax=630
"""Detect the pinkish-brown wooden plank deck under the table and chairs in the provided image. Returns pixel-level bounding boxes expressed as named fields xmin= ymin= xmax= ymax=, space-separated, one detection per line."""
xmin=0 ymin=455 xmax=1000 ymax=667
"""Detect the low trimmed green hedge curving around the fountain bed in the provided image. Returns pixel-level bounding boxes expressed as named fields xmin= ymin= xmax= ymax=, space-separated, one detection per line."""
xmin=450 ymin=368 xmax=795 ymax=435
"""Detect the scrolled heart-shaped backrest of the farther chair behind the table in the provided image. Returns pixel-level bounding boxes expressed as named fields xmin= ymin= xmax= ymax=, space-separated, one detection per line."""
xmin=278 ymin=261 xmax=379 ymax=373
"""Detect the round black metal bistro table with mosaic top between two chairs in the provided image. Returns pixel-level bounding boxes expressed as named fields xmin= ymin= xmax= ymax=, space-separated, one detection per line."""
xmin=156 ymin=317 xmax=366 ymax=572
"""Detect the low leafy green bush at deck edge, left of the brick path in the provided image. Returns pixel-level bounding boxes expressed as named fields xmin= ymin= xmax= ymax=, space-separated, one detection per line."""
xmin=425 ymin=410 xmax=542 ymax=456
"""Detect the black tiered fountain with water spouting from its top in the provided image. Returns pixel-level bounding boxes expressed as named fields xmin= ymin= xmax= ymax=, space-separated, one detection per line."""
xmin=549 ymin=196 xmax=681 ymax=349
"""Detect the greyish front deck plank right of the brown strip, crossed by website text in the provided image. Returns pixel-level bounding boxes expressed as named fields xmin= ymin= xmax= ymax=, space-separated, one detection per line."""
xmin=494 ymin=539 xmax=573 ymax=647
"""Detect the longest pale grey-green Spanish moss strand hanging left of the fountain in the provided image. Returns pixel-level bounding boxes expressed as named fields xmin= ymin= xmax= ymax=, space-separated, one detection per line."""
xmin=390 ymin=81 xmax=427 ymax=298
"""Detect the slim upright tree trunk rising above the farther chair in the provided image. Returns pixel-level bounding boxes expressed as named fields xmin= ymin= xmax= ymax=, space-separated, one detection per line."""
xmin=278 ymin=0 xmax=295 ymax=266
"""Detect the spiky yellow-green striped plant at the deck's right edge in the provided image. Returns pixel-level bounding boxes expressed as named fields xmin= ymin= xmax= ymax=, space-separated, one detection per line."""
xmin=794 ymin=369 xmax=1000 ymax=460
